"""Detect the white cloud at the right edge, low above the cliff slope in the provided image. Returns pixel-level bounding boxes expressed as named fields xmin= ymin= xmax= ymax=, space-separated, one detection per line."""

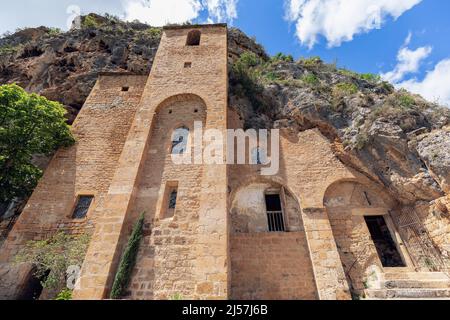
xmin=397 ymin=59 xmax=450 ymax=107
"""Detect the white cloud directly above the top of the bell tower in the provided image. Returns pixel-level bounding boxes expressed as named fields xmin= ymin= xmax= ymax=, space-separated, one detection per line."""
xmin=122 ymin=0 xmax=238 ymax=26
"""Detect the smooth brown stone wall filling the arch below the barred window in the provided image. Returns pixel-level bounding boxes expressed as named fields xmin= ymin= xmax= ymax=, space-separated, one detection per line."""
xmin=230 ymin=232 xmax=317 ymax=300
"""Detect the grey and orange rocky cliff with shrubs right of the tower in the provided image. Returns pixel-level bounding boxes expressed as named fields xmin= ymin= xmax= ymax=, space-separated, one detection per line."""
xmin=230 ymin=55 xmax=450 ymax=205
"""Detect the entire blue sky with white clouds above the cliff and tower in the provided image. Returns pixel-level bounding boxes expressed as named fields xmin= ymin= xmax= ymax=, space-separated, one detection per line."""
xmin=0 ymin=0 xmax=450 ymax=105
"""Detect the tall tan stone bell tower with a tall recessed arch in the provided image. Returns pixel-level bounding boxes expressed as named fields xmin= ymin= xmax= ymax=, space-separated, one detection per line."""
xmin=74 ymin=24 xmax=229 ymax=299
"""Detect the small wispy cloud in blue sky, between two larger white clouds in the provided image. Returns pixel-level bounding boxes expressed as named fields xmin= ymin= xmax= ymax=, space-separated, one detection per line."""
xmin=381 ymin=33 xmax=433 ymax=83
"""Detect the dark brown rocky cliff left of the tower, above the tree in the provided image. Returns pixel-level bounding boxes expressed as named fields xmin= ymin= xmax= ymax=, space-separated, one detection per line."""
xmin=0 ymin=15 xmax=161 ymax=121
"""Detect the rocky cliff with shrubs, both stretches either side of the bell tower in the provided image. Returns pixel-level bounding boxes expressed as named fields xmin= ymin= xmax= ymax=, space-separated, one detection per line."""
xmin=0 ymin=14 xmax=450 ymax=207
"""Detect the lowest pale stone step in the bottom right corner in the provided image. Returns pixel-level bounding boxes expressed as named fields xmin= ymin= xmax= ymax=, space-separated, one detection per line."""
xmin=364 ymin=289 xmax=450 ymax=300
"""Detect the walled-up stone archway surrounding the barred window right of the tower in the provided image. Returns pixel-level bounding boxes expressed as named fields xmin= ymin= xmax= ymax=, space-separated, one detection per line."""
xmin=230 ymin=178 xmax=317 ymax=300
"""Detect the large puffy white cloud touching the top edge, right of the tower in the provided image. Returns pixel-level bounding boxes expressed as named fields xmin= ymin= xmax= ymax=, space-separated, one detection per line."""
xmin=285 ymin=0 xmax=422 ymax=48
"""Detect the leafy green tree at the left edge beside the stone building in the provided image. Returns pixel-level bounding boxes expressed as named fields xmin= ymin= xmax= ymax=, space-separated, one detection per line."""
xmin=0 ymin=84 xmax=74 ymax=202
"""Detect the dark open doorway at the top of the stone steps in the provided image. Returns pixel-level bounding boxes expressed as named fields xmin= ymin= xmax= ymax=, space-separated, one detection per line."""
xmin=364 ymin=216 xmax=406 ymax=268
